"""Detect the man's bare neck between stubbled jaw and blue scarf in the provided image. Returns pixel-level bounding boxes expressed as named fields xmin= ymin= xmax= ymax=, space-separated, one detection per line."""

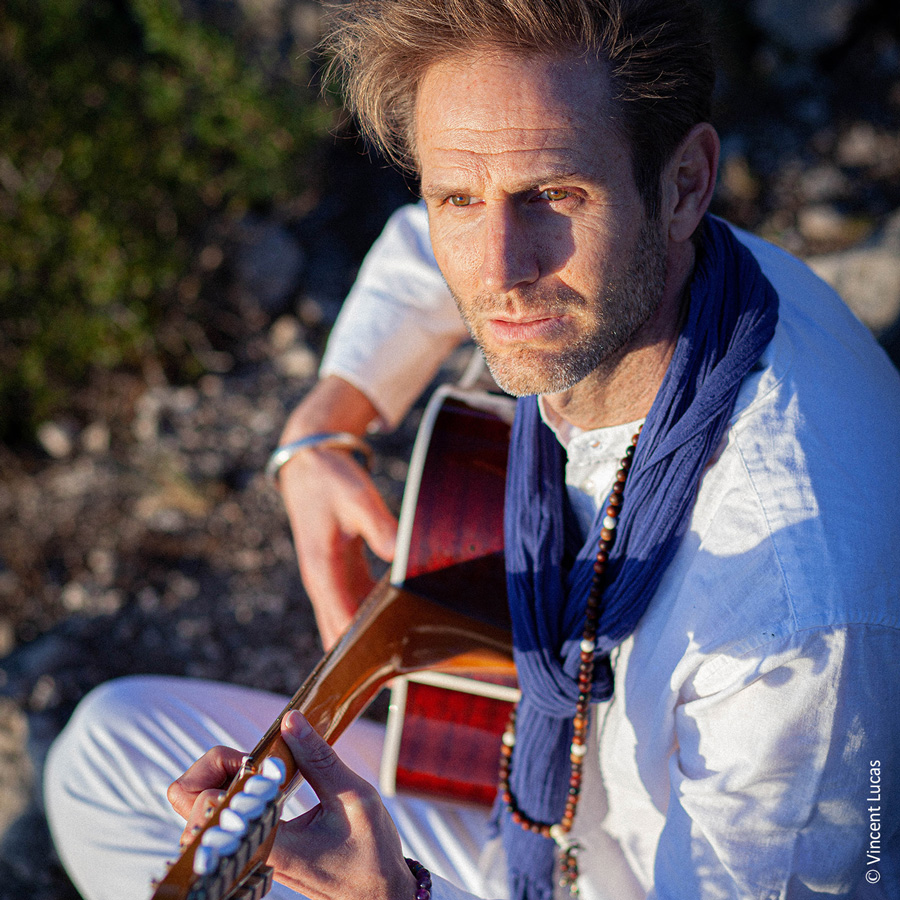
xmin=544 ymin=245 xmax=695 ymax=431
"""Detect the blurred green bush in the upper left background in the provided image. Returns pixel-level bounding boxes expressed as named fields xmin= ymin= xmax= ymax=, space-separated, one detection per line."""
xmin=0 ymin=0 xmax=327 ymax=440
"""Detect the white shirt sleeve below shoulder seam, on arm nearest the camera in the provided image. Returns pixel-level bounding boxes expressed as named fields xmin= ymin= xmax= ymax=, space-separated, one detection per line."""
xmin=650 ymin=625 xmax=900 ymax=900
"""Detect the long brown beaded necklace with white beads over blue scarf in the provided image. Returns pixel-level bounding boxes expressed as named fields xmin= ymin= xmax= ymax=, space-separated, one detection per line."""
xmin=499 ymin=429 xmax=640 ymax=894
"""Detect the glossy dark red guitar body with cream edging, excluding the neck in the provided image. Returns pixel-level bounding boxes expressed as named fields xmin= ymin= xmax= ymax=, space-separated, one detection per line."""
xmin=379 ymin=387 xmax=518 ymax=806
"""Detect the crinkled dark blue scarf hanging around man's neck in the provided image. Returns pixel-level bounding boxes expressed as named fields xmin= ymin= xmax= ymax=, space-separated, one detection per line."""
xmin=498 ymin=216 xmax=778 ymax=900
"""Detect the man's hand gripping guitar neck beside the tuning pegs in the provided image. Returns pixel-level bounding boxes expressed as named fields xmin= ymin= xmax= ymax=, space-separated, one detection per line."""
xmin=169 ymin=711 xmax=416 ymax=900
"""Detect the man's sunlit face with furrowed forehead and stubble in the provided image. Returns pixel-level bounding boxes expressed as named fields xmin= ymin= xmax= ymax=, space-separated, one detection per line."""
xmin=416 ymin=52 xmax=666 ymax=395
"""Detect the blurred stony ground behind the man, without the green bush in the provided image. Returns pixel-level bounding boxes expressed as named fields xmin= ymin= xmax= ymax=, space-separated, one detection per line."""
xmin=0 ymin=3 xmax=900 ymax=900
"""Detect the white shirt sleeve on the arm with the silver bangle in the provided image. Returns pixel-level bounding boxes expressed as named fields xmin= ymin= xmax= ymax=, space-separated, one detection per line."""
xmin=320 ymin=203 xmax=468 ymax=428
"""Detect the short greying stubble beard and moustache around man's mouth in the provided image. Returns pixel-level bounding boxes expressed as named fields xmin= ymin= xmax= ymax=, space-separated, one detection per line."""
xmin=454 ymin=221 xmax=666 ymax=397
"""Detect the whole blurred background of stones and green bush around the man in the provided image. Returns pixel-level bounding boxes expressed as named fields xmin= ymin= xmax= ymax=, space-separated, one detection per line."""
xmin=0 ymin=0 xmax=900 ymax=900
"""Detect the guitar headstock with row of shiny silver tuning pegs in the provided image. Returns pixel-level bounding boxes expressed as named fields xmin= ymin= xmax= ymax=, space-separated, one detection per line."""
xmin=151 ymin=756 xmax=290 ymax=900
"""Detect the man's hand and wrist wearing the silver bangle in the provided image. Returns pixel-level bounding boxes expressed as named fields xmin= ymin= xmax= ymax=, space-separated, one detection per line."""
xmin=278 ymin=376 xmax=397 ymax=650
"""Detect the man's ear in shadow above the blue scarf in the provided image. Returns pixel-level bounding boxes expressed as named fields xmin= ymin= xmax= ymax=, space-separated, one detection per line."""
xmin=662 ymin=122 xmax=719 ymax=243
